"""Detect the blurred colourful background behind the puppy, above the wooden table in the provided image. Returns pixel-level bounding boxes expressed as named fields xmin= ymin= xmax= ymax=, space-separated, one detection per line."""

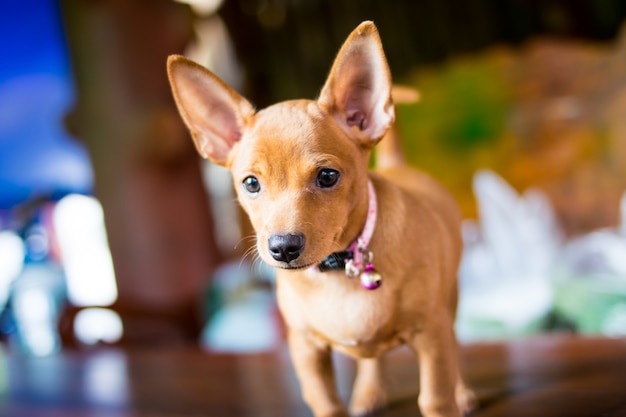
xmin=0 ymin=0 xmax=626 ymax=355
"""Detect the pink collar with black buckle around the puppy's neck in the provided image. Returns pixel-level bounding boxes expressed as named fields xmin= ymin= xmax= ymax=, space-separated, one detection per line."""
xmin=317 ymin=180 xmax=378 ymax=272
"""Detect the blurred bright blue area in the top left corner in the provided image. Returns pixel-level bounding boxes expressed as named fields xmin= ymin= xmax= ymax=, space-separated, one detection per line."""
xmin=0 ymin=0 xmax=93 ymax=210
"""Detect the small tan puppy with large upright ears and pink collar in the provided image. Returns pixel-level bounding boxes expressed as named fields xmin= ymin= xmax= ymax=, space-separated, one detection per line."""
xmin=168 ymin=22 xmax=474 ymax=417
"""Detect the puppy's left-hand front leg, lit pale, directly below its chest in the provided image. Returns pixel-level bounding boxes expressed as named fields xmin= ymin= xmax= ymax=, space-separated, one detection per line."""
xmin=289 ymin=330 xmax=348 ymax=417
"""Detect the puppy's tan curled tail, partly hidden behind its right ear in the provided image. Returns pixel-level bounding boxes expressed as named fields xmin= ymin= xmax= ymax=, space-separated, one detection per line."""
xmin=376 ymin=84 xmax=420 ymax=169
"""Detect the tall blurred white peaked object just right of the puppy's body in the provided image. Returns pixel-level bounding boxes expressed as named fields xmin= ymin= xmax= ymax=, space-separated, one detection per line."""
xmin=457 ymin=171 xmax=561 ymax=340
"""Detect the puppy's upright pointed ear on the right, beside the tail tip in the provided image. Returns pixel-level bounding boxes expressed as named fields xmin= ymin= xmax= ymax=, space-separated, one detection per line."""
xmin=318 ymin=22 xmax=394 ymax=147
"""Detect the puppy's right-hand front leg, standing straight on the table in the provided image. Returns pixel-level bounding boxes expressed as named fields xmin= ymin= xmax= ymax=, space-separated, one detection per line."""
xmin=411 ymin=311 xmax=461 ymax=417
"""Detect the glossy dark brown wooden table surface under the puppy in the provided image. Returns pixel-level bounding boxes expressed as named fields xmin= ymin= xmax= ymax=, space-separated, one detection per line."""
xmin=0 ymin=336 xmax=626 ymax=417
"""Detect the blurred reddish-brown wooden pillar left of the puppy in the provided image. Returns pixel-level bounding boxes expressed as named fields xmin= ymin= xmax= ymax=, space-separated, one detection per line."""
xmin=62 ymin=0 xmax=219 ymax=343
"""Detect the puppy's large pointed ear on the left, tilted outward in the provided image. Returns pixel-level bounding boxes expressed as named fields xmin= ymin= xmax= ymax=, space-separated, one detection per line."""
xmin=167 ymin=55 xmax=254 ymax=166
